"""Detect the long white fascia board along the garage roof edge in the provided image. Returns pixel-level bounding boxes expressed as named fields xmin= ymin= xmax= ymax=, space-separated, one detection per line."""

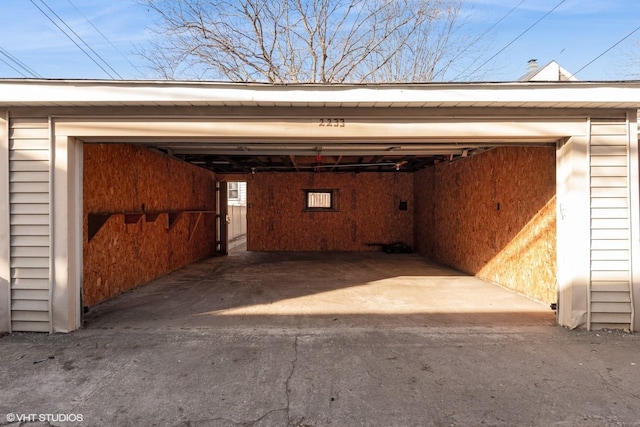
xmin=0 ymin=80 xmax=640 ymax=108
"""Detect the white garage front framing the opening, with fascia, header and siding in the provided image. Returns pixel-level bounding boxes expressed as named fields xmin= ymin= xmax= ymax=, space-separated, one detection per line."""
xmin=0 ymin=81 xmax=640 ymax=332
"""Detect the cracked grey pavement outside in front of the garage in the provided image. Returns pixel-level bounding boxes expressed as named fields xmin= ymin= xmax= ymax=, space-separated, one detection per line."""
xmin=0 ymin=327 xmax=640 ymax=426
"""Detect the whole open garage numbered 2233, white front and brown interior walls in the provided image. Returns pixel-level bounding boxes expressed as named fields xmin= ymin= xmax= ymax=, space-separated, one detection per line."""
xmin=0 ymin=80 xmax=640 ymax=332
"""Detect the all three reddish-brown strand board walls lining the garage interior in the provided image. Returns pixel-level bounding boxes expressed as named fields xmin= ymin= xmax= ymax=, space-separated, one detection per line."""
xmin=83 ymin=140 xmax=557 ymax=324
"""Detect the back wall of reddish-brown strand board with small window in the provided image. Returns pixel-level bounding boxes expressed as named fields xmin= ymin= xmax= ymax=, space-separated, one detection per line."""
xmin=247 ymin=172 xmax=414 ymax=251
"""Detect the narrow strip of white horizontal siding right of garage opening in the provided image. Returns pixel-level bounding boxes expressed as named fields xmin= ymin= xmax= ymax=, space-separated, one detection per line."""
xmin=589 ymin=119 xmax=632 ymax=329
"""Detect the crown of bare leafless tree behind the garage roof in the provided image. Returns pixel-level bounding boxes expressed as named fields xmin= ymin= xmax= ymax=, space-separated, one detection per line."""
xmin=138 ymin=0 xmax=484 ymax=83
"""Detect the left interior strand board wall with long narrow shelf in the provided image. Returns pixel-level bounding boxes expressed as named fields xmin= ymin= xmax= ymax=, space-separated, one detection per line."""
xmin=83 ymin=144 xmax=216 ymax=306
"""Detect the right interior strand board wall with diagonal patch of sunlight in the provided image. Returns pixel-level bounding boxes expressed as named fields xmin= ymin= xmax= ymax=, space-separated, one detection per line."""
xmin=414 ymin=148 xmax=556 ymax=303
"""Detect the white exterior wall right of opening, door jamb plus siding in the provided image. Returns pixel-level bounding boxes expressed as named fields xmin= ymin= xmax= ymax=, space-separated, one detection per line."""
xmin=556 ymin=111 xmax=640 ymax=330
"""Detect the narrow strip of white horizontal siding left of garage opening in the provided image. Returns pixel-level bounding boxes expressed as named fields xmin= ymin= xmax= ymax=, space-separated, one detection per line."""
xmin=9 ymin=118 xmax=51 ymax=332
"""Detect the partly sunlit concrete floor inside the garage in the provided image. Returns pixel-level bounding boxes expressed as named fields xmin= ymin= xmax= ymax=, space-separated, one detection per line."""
xmin=85 ymin=251 xmax=555 ymax=328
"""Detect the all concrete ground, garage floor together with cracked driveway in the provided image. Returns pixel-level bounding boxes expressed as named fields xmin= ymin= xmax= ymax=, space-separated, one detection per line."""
xmin=0 ymin=252 xmax=640 ymax=426
